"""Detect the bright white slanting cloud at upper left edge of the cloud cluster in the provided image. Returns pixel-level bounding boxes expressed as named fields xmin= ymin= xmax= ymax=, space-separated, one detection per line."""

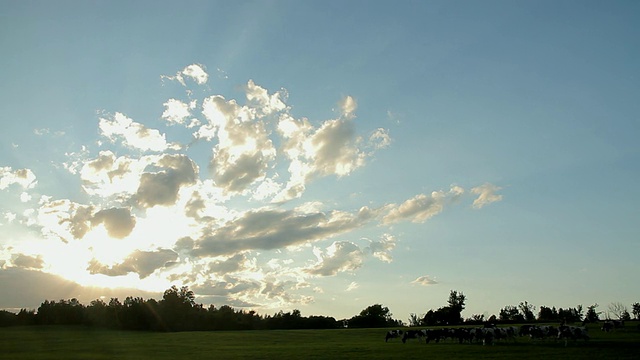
xmin=99 ymin=112 xmax=179 ymax=152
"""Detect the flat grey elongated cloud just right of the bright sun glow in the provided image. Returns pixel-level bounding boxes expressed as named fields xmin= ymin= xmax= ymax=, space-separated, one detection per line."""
xmin=87 ymin=249 xmax=178 ymax=279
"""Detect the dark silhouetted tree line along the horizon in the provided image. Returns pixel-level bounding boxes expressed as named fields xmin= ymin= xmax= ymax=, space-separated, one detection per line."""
xmin=0 ymin=286 xmax=640 ymax=331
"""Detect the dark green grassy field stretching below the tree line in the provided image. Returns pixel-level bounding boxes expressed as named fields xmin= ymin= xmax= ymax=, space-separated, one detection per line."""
xmin=0 ymin=323 xmax=640 ymax=360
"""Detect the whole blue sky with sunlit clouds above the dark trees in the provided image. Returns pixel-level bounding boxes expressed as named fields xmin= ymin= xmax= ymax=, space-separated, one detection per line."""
xmin=0 ymin=0 xmax=640 ymax=321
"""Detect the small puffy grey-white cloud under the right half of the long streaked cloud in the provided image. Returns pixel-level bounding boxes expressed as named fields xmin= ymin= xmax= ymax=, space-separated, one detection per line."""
xmin=305 ymin=241 xmax=365 ymax=276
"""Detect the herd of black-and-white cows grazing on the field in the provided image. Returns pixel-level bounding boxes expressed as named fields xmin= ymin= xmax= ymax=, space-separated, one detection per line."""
xmin=384 ymin=324 xmax=589 ymax=346
